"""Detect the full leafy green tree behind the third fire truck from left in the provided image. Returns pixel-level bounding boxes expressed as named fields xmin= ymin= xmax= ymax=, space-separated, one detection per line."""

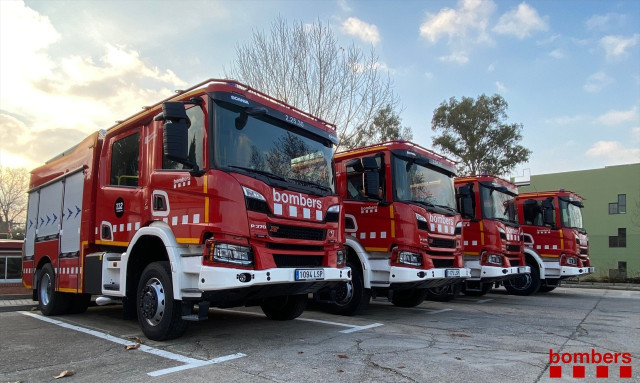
xmin=431 ymin=94 xmax=531 ymax=176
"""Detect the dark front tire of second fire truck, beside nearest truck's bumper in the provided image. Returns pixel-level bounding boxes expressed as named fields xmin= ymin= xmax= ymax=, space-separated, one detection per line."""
xmin=329 ymin=261 xmax=371 ymax=316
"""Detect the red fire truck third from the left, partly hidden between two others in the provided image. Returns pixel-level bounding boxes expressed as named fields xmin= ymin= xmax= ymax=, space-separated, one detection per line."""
xmin=454 ymin=175 xmax=530 ymax=296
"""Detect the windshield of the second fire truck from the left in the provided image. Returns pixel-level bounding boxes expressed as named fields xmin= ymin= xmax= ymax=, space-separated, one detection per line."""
xmin=393 ymin=157 xmax=456 ymax=209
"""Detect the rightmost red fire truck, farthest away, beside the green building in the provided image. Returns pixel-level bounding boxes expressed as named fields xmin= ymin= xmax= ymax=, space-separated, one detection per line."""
xmin=505 ymin=190 xmax=594 ymax=295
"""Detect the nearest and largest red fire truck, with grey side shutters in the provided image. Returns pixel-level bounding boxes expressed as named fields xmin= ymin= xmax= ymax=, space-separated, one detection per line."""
xmin=23 ymin=79 xmax=350 ymax=340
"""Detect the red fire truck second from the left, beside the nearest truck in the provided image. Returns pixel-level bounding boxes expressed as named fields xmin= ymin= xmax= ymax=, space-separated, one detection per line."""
xmin=317 ymin=141 xmax=469 ymax=315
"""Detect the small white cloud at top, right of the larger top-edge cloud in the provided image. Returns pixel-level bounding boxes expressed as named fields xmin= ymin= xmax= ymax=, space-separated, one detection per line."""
xmin=493 ymin=3 xmax=549 ymax=40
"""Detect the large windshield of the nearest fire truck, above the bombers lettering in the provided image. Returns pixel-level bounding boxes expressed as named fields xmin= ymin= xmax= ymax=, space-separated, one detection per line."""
xmin=213 ymin=101 xmax=334 ymax=192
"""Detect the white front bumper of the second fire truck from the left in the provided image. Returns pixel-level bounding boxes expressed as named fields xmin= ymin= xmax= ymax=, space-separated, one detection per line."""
xmin=389 ymin=266 xmax=471 ymax=290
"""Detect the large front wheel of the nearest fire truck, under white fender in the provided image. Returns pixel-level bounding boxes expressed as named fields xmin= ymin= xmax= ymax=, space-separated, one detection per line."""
xmin=136 ymin=261 xmax=187 ymax=341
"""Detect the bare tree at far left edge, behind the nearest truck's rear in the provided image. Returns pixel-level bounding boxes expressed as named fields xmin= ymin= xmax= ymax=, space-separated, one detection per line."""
xmin=0 ymin=166 xmax=29 ymax=238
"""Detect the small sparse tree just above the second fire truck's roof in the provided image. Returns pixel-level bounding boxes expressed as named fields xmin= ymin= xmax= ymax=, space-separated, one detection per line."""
xmin=343 ymin=104 xmax=413 ymax=147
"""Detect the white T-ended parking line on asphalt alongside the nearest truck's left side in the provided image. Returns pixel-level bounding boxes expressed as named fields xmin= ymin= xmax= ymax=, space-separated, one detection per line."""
xmin=20 ymin=311 xmax=247 ymax=376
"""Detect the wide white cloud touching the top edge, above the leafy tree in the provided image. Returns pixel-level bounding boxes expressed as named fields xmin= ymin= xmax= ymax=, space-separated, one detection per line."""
xmin=420 ymin=0 xmax=496 ymax=44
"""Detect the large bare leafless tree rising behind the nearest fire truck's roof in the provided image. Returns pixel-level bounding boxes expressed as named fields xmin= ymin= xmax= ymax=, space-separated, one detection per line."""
xmin=225 ymin=17 xmax=398 ymax=149
